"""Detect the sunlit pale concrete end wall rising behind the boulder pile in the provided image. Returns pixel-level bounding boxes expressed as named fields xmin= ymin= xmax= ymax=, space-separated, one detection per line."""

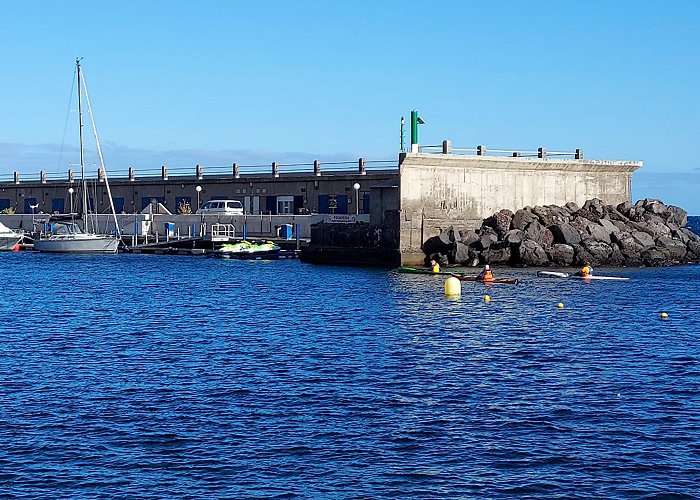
xmin=399 ymin=153 xmax=642 ymax=265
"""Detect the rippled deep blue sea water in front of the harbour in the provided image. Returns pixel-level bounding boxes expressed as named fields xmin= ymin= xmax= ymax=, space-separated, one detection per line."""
xmin=0 ymin=252 xmax=700 ymax=499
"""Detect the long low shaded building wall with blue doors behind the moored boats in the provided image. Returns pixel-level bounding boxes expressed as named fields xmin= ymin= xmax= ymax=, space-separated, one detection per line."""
xmin=0 ymin=173 xmax=397 ymax=215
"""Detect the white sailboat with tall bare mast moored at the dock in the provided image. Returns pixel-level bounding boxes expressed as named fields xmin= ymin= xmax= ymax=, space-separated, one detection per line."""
xmin=34 ymin=59 xmax=121 ymax=253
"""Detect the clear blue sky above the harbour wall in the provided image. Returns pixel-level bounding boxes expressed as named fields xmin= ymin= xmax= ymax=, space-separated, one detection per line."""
xmin=0 ymin=0 xmax=700 ymax=214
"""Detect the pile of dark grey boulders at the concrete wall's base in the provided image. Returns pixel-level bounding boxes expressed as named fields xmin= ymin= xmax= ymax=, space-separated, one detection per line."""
xmin=421 ymin=198 xmax=700 ymax=267
